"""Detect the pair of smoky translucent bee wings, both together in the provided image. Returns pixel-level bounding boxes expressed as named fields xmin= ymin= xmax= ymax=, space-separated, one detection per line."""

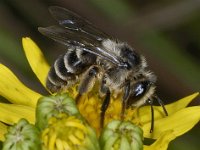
xmin=38 ymin=6 xmax=120 ymax=65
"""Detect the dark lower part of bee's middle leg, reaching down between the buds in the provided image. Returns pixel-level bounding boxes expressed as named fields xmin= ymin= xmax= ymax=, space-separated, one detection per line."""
xmin=100 ymin=88 xmax=110 ymax=128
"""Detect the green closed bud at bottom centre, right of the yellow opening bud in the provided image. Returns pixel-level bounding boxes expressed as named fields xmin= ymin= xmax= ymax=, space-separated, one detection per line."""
xmin=100 ymin=120 xmax=143 ymax=150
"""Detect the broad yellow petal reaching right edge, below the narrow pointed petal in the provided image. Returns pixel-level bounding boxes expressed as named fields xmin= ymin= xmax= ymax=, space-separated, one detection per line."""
xmin=142 ymin=106 xmax=200 ymax=139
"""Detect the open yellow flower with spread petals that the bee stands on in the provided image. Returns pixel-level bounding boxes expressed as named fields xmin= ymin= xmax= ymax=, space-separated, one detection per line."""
xmin=0 ymin=38 xmax=200 ymax=150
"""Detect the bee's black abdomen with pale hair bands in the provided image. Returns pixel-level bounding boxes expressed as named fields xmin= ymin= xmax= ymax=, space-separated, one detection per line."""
xmin=46 ymin=48 xmax=96 ymax=93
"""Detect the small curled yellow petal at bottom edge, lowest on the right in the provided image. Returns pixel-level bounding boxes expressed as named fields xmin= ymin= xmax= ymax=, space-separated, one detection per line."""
xmin=144 ymin=130 xmax=176 ymax=150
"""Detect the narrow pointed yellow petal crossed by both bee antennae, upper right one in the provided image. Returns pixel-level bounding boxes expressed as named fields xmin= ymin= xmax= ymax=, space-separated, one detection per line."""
xmin=138 ymin=92 xmax=199 ymax=125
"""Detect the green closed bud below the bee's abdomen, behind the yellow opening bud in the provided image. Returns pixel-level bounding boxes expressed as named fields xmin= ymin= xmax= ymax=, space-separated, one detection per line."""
xmin=36 ymin=94 xmax=82 ymax=130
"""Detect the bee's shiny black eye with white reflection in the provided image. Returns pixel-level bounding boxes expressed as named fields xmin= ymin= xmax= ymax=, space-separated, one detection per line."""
xmin=133 ymin=81 xmax=150 ymax=97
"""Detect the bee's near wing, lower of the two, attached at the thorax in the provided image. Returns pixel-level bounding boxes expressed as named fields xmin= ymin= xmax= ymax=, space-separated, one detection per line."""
xmin=38 ymin=26 xmax=120 ymax=65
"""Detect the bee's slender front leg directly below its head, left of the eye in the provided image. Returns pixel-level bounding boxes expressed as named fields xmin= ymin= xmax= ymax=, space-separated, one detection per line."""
xmin=121 ymin=81 xmax=130 ymax=120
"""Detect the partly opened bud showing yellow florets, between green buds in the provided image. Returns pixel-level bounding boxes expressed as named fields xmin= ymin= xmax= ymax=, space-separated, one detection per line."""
xmin=42 ymin=114 xmax=100 ymax=150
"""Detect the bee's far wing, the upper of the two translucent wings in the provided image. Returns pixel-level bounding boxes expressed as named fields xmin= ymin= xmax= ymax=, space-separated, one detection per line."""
xmin=49 ymin=6 xmax=111 ymax=41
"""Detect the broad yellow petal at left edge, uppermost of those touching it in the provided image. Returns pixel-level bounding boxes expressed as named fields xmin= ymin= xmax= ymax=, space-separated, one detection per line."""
xmin=0 ymin=64 xmax=41 ymax=107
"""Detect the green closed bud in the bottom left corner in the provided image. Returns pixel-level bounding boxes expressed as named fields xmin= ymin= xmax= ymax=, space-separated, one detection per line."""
xmin=2 ymin=119 xmax=41 ymax=150
